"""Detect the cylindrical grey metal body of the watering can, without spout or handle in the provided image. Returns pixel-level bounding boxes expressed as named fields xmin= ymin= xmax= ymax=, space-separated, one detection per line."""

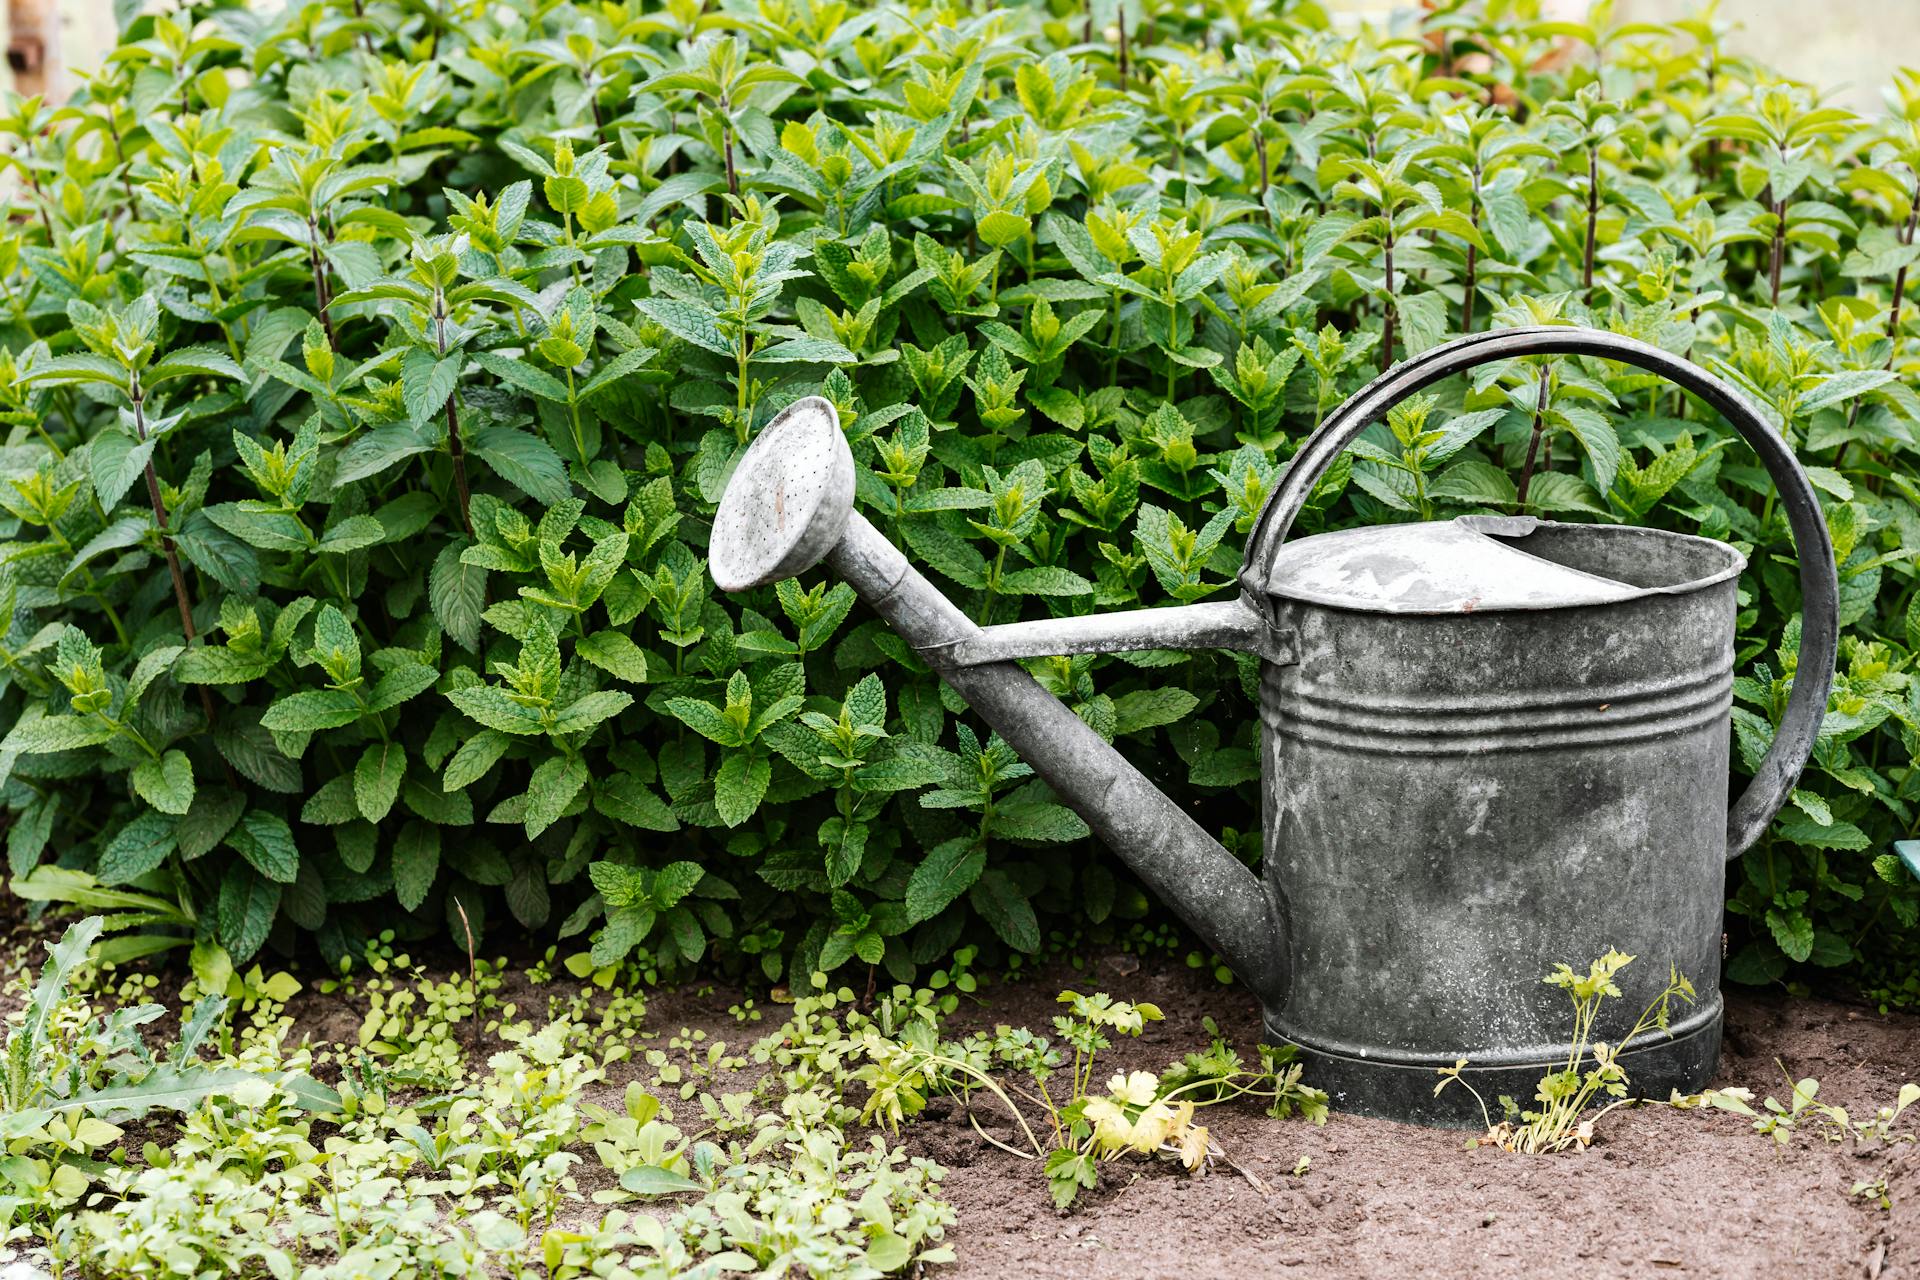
xmin=1260 ymin=516 xmax=1745 ymax=1123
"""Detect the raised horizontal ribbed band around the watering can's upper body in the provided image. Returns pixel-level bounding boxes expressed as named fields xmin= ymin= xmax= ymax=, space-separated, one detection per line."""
xmin=1261 ymin=666 xmax=1734 ymax=756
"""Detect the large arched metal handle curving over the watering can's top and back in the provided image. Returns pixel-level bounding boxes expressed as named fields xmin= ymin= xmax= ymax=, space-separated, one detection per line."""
xmin=1240 ymin=326 xmax=1839 ymax=858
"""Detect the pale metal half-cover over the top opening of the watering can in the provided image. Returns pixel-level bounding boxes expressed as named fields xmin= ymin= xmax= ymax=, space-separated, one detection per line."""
xmin=1267 ymin=516 xmax=1649 ymax=614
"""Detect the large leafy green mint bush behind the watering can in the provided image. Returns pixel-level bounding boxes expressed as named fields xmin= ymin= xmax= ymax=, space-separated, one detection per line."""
xmin=0 ymin=0 xmax=1920 ymax=990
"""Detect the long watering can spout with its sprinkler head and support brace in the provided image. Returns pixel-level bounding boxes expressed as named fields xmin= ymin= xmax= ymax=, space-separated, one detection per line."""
xmin=708 ymin=397 xmax=1288 ymax=1004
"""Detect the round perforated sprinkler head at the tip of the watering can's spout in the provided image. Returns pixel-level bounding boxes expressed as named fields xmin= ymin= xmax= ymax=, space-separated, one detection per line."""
xmin=707 ymin=395 xmax=854 ymax=591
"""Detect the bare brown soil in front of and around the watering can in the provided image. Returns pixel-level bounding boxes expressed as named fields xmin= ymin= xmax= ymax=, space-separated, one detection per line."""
xmin=904 ymin=954 xmax=1920 ymax=1280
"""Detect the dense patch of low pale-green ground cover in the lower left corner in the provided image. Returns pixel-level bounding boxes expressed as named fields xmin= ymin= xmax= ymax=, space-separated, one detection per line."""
xmin=0 ymin=917 xmax=967 ymax=1280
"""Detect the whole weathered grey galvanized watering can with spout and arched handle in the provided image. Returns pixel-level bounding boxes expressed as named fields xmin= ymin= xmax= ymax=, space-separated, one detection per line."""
xmin=710 ymin=328 xmax=1837 ymax=1125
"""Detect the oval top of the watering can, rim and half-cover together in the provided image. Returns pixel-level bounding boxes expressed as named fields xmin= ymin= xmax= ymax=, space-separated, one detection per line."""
xmin=1261 ymin=514 xmax=1747 ymax=616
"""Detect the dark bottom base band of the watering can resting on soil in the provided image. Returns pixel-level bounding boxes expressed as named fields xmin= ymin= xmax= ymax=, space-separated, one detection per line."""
xmin=1263 ymin=996 xmax=1724 ymax=1128
